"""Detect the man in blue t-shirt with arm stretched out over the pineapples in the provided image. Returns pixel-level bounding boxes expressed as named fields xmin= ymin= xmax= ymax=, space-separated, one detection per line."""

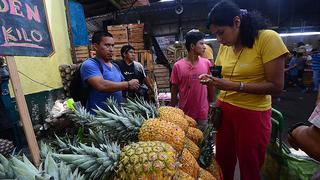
xmin=80 ymin=31 xmax=139 ymax=114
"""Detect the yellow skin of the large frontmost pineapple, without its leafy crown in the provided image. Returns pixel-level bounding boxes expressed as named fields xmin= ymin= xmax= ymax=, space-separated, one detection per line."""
xmin=116 ymin=141 xmax=178 ymax=180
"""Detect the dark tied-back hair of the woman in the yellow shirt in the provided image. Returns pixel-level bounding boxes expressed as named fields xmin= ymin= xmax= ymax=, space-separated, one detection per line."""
xmin=208 ymin=0 xmax=268 ymax=48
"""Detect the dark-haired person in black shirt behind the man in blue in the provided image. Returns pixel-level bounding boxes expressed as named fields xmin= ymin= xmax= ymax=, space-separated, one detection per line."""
xmin=115 ymin=45 xmax=153 ymax=100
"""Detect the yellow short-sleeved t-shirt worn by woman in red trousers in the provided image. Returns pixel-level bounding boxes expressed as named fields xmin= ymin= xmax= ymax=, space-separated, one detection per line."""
xmin=215 ymin=30 xmax=288 ymax=111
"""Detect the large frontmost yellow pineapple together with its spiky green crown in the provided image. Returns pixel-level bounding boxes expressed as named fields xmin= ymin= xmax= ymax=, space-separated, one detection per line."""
xmin=55 ymin=141 xmax=179 ymax=180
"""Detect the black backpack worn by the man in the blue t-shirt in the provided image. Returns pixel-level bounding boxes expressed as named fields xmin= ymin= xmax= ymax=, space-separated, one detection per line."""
xmin=70 ymin=58 xmax=103 ymax=106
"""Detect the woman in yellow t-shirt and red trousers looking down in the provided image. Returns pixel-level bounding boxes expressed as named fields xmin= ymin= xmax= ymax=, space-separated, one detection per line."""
xmin=199 ymin=1 xmax=288 ymax=180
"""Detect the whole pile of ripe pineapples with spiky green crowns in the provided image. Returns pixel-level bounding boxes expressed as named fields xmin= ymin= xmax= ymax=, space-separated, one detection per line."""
xmin=0 ymin=99 xmax=221 ymax=180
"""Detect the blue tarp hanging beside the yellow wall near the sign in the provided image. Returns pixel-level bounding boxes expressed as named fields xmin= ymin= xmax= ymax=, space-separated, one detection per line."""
xmin=69 ymin=0 xmax=89 ymax=46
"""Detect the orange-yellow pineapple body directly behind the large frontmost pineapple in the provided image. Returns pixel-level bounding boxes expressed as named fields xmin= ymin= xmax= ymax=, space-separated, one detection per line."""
xmin=138 ymin=119 xmax=185 ymax=153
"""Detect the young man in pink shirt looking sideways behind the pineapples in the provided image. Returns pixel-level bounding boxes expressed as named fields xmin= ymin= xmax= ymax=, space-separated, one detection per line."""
xmin=170 ymin=31 xmax=214 ymax=130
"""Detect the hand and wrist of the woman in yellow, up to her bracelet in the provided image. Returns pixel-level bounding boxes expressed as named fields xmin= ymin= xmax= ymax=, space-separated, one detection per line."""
xmin=199 ymin=74 xmax=240 ymax=91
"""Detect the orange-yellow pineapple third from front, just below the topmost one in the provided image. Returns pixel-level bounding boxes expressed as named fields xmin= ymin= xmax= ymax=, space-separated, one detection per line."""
xmin=160 ymin=111 xmax=189 ymax=132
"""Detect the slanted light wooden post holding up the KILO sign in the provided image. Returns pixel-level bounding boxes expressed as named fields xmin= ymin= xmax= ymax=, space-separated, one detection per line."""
xmin=6 ymin=56 xmax=40 ymax=166
